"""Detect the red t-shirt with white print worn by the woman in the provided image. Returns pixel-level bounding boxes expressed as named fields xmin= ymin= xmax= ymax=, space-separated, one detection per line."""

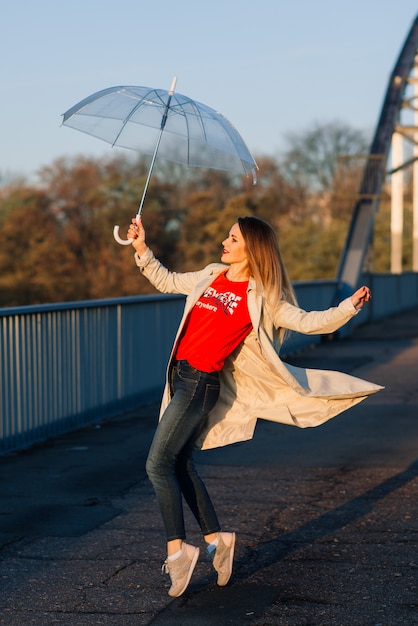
xmin=176 ymin=273 xmax=252 ymax=372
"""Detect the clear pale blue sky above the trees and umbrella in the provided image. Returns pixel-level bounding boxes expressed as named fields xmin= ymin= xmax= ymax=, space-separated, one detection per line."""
xmin=0 ymin=0 xmax=418 ymax=177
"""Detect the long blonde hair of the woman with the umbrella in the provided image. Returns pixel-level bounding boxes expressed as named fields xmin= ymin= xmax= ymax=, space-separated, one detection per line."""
xmin=238 ymin=216 xmax=297 ymax=309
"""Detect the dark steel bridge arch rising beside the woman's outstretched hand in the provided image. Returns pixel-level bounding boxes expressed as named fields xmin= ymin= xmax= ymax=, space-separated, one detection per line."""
xmin=337 ymin=15 xmax=418 ymax=299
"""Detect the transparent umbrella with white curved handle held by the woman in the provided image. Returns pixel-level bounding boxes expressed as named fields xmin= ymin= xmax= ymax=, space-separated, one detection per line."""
xmin=62 ymin=78 xmax=257 ymax=245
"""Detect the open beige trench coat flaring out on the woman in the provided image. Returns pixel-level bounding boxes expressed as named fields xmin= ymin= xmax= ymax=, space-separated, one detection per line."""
xmin=135 ymin=249 xmax=383 ymax=449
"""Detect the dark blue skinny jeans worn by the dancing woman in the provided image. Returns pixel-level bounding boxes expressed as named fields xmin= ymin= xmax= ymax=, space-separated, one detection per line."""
xmin=146 ymin=361 xmax=220 ymax=541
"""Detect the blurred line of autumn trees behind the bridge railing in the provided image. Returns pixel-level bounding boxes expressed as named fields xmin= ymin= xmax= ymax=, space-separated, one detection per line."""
xmin=0 ymin=123 xmax=410 ymax=307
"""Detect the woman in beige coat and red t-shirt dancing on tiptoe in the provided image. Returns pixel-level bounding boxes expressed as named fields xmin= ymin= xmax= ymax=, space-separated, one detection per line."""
xmin=128 ymin=217 xmax=381 ymax=597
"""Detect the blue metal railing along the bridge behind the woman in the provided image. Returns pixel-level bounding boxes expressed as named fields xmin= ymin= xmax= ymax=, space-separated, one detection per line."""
xmin=0 ymin=272 xmax=418 ymax=454
